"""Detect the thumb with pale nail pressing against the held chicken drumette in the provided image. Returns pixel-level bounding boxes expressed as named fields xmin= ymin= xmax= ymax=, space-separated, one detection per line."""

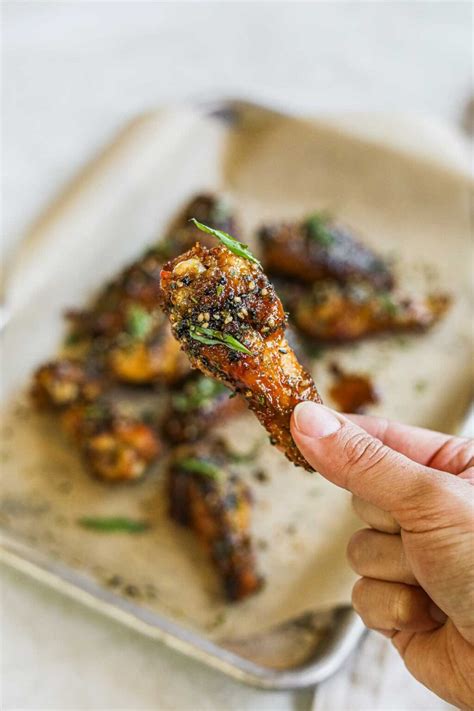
xmin=291 ymin=402 xmax=454 ymax=526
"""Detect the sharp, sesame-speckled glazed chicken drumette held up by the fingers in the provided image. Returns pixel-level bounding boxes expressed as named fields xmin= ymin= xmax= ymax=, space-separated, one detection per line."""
xmin=161 ymin=244 xmax=320 ymax=469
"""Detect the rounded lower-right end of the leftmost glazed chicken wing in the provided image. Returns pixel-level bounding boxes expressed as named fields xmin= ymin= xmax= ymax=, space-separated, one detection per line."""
xmin=60 ymin=403 xmax=160 ymax=483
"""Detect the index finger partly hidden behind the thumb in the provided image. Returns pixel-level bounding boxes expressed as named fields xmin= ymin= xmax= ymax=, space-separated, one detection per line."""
xmin=345 ymin=415 xmax=474 ymax=474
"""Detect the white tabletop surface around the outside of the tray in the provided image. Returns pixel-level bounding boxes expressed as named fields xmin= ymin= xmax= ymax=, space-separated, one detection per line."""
xmin=1 ymin=2 xmax=472 ymax=711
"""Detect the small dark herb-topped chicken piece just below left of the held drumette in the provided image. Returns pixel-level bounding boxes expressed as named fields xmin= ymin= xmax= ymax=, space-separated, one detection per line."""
xmin=163 ymin=371 xmax=244 ymax=444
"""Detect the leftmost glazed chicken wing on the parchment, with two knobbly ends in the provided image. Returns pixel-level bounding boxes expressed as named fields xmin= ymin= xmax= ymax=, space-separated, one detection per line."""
xmin=32 ymin=359 xmax=160 ymax=482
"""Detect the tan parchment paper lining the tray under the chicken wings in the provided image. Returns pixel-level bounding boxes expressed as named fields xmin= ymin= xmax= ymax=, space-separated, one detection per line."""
xmin=0 ymin=108 xmax=472 ymax=639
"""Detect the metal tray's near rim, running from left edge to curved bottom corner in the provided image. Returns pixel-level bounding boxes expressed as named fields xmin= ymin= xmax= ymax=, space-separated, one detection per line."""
xmin=0 ymin=532 xmax=366 ymax=691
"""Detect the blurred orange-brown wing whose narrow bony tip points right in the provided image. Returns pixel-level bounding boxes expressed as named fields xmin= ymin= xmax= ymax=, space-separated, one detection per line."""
xmin=292 ymin=281 xmax=450 ymax=343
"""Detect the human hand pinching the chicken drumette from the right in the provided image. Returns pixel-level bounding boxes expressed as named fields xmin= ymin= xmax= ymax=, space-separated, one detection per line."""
xmin=291 ymin=402 xmax=474 ymax=708
